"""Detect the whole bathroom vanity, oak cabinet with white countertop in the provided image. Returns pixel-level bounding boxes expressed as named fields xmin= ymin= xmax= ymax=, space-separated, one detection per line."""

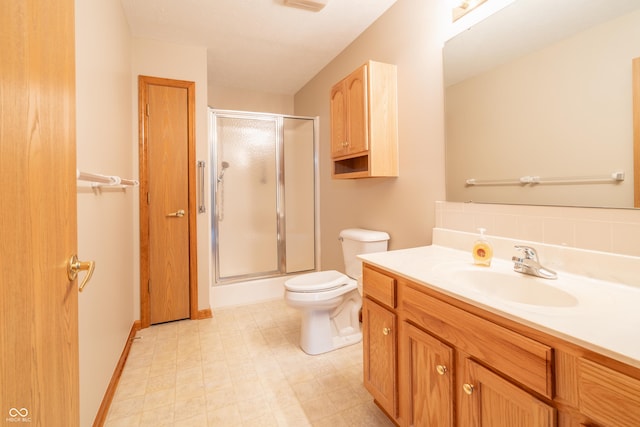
xmin=361 ymin=246 xmax=640 ymax=427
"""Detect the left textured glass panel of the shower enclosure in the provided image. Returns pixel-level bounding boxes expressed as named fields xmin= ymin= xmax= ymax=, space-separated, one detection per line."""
xmin=213 ymin=115 xmax=279 ymax=280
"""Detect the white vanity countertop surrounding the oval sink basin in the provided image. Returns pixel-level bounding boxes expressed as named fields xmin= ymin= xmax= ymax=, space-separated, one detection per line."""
xmin=359 ymin=245 xmax=640 ymax=368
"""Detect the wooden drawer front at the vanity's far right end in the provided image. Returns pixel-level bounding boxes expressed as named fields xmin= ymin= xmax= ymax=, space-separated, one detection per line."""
xmin=578 ymin=358 xmax=640 ymax=426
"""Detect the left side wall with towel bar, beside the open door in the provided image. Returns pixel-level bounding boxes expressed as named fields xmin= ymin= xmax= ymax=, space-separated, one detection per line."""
xmin=74 ymin=0 xmax=138 ymax=426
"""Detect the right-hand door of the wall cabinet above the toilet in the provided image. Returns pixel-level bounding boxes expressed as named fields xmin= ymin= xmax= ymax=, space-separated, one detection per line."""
xmin=345 ymin=65 xmax=369 ymax=154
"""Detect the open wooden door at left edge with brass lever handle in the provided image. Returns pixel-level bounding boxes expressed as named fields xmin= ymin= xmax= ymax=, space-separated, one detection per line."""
xmin=0 ymin=0 xmax=80 ymax=426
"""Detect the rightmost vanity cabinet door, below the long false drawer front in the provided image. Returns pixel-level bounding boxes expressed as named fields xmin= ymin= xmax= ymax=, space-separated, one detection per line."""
xmin=459 ymin=359 xmax=557 ymax=427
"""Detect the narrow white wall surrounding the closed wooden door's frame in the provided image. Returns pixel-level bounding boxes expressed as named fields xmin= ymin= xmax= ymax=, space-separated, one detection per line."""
xmin=130 ymin=38 xmax=211 ymax=319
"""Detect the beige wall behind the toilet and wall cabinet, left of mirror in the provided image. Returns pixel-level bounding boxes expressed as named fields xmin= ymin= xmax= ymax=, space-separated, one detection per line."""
xmin=295 ymin=0 xmax=451 ymax=270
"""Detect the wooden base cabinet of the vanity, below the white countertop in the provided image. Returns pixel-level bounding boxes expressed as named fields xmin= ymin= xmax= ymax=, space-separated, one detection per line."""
xmin=363 ymin=263 xmax=640 ymax=427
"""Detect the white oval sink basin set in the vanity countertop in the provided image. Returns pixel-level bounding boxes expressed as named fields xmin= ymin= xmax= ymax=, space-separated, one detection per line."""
xmin=434 ymin=263 xmax=578 ymax=308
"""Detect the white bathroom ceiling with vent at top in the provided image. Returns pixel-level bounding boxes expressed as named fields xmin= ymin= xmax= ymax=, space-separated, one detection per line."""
xmin=121 ymin=0 xmax=396 ymax=95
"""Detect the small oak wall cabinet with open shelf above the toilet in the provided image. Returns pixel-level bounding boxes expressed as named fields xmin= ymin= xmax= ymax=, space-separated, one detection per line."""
xmin=330 ymin=61 xmax=398 ymax=178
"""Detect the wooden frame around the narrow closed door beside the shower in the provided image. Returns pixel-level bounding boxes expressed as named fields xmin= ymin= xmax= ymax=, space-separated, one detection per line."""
xmin=138 ymin=75 xmax=199 ymax=328
